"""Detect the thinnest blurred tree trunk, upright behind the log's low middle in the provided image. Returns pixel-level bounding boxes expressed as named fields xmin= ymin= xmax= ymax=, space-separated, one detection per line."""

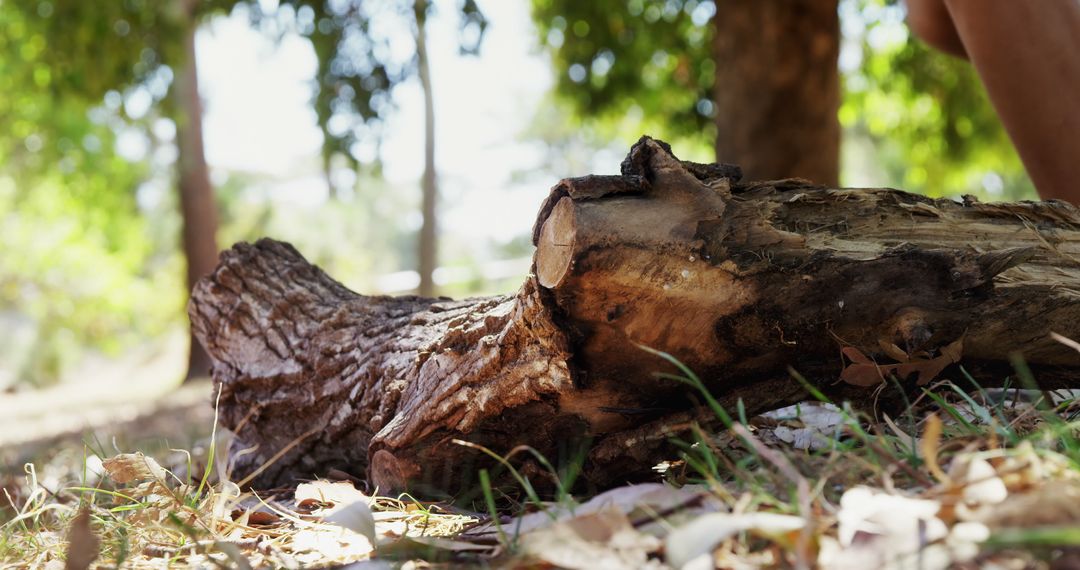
xmin=413 ymin=0 xmax=438 ymax=297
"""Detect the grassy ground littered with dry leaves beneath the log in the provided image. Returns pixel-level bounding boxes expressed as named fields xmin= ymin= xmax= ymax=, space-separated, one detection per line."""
xmin=0 ymin=362 xmax=1080 ymax=570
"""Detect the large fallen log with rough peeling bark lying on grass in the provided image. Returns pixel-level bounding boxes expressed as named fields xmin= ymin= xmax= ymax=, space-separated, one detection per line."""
xmin=189 ymin=137 xmax=1080 ymax=490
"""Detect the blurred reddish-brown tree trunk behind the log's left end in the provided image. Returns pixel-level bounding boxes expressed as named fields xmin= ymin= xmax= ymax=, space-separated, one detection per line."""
xmin=174 ymin=16 xmax=217 ymax=379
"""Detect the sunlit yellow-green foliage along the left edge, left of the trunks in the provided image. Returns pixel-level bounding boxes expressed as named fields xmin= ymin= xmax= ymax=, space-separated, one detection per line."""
xmin=0 ymin=2 xmax=183 ymax=388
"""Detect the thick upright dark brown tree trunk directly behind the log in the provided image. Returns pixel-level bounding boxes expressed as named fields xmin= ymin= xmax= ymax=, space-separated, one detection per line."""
xmin=713 ymin=0 xmax=840 ymax=186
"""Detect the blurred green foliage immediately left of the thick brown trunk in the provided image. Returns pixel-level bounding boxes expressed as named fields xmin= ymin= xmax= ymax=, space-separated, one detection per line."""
xmin=532 ymin=0 xmax=716 ymax=148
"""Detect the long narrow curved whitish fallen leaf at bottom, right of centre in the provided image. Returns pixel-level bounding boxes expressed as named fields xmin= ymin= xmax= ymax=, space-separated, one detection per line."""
xmin=664 ymin=513 xmax=806 ymax=568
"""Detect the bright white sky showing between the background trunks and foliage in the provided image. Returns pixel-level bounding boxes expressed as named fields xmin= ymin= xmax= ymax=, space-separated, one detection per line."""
xmin=198 ymin=2 xmax=561 ymax=240
